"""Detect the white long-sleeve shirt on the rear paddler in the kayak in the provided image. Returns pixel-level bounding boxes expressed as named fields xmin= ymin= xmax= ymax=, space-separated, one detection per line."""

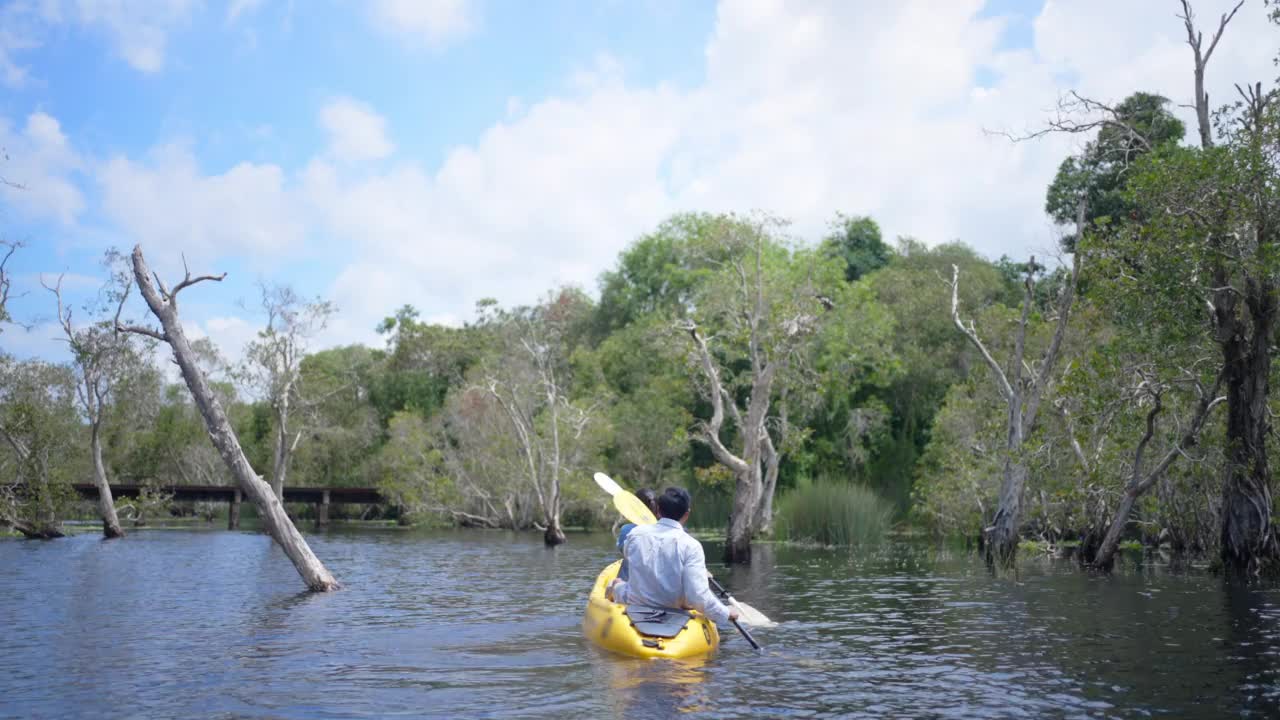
xmin=613 ymin=518 xmax=728 ymax=623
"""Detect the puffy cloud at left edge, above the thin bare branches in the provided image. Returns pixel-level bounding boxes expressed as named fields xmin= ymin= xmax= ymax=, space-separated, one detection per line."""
xmin=0 ymin=111 xmax=84 ymax=225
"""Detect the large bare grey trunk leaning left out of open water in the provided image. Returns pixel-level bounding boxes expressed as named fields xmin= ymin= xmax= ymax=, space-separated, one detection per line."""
xmin=116 ymin=246 xmax=339 ymax=592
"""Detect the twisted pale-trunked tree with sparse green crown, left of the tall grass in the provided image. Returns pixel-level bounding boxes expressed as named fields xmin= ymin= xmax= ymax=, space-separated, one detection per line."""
xmin=677 ymin=215 xmax=847 ymax=562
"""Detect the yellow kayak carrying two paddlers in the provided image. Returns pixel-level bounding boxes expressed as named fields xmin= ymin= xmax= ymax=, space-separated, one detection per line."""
xmin=582 ymin=560 xmax=719 ymax=657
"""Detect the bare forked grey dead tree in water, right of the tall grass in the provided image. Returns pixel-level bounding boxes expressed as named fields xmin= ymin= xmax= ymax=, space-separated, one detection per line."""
xmin=951 ymin=200 xmax=1087 ymax=565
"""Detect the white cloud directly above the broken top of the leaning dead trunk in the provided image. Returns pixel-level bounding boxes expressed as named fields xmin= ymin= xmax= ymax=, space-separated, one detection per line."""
xmin=96 ymin=145 xmax=306 ymax=268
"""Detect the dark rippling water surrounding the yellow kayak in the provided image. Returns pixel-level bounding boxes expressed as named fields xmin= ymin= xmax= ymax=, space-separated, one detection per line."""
xmin=0 ymin=530 xmax=1280 ymax=719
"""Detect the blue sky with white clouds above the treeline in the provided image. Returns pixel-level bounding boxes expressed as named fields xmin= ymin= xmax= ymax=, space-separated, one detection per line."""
xmin=0 ymin=0 xmax=1280 ymax=359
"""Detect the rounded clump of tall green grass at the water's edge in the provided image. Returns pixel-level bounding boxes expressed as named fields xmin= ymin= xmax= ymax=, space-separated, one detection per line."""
xmin=776 ymin=479 xmax=893 ymax=546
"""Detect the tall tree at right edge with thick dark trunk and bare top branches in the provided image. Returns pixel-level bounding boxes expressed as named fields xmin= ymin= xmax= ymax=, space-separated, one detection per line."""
xmin=1095 ymin=1 xmax=1280 ymax=573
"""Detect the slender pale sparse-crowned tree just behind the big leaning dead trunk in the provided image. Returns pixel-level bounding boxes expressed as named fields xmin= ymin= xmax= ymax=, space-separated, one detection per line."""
xmin=242 ymin=284 xmax=335 ymax=500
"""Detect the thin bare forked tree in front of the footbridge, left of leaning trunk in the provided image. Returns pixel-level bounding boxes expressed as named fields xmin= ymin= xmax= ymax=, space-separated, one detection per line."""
xmin=41 ymin=275 xmax=132 ymax=539
